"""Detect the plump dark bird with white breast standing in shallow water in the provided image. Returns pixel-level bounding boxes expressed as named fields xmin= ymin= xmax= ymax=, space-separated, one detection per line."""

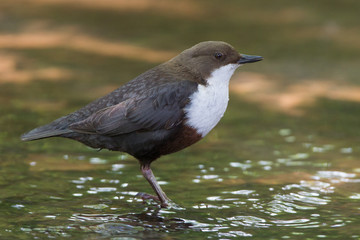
xmin=21 ymin=41 xmax=263 ymax=208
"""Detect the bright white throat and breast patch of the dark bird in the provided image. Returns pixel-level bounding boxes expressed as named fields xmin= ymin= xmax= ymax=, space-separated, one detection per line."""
xmin=185 ymin=64 xmax=239 ymax=137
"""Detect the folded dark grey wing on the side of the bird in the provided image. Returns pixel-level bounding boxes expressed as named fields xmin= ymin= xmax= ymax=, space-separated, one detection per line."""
xmin=70 ymin=81 xmax=197 ymax=136
